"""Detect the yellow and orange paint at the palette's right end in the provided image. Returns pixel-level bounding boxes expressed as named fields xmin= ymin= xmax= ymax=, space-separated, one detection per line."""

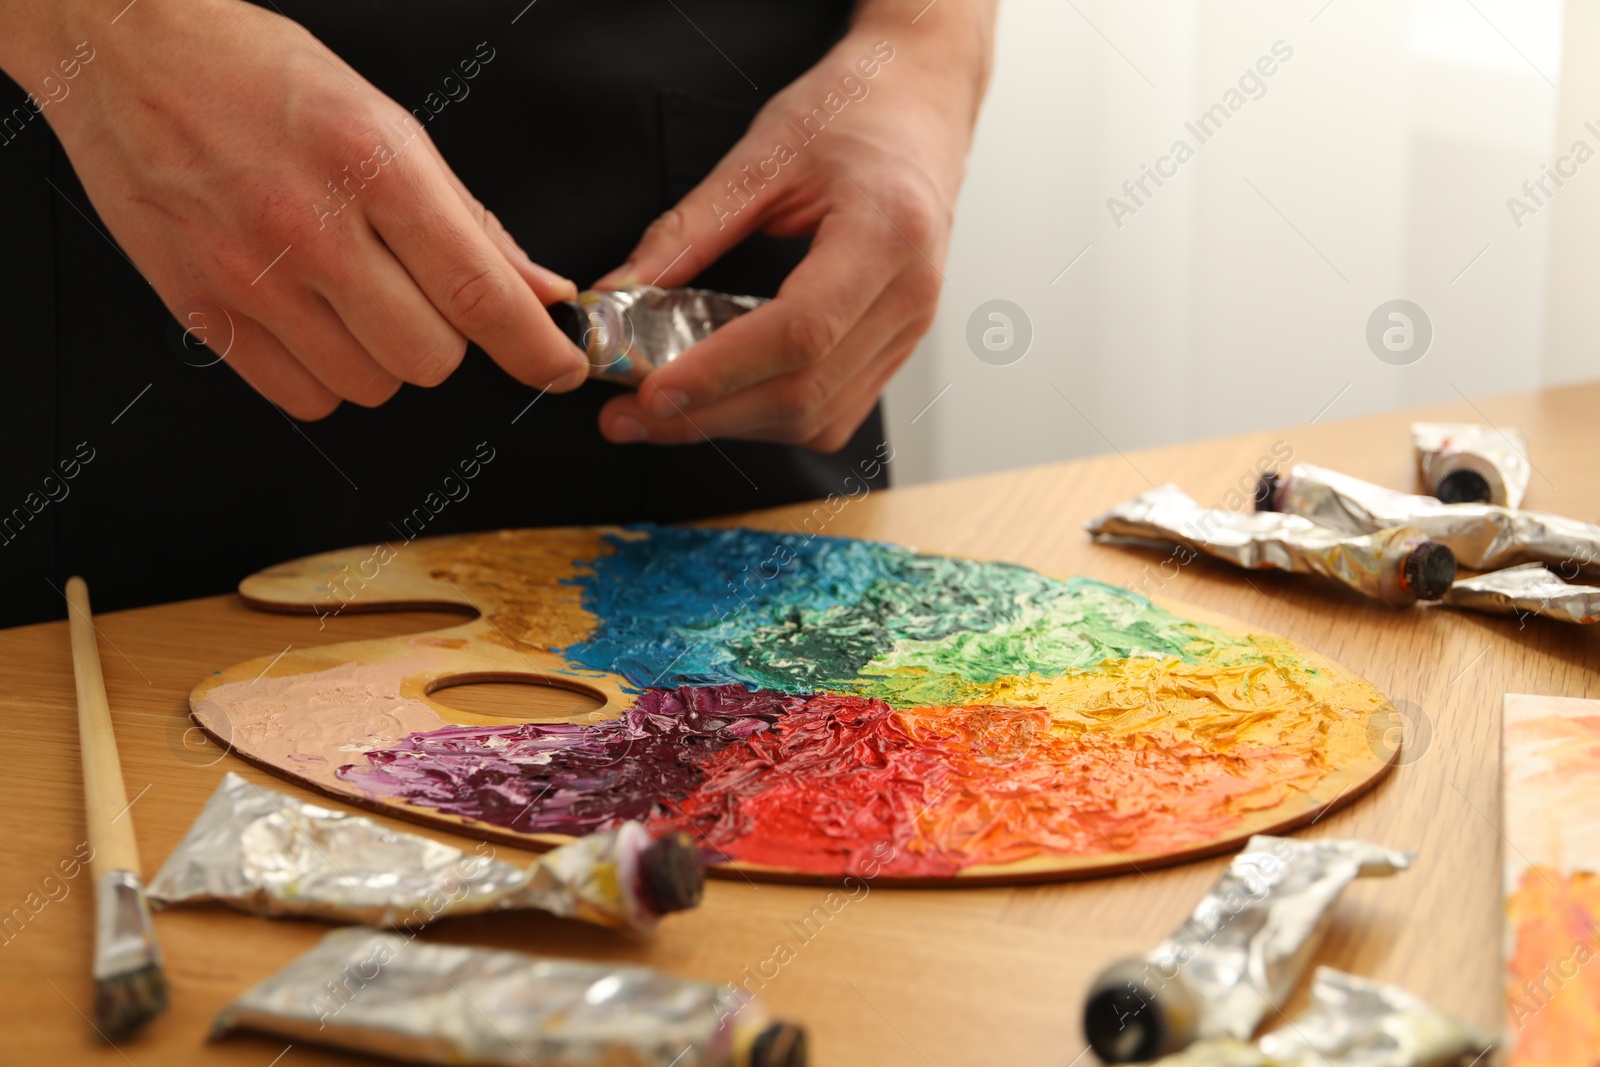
xmin=851 ymin=638 xmax=1389 ymax=862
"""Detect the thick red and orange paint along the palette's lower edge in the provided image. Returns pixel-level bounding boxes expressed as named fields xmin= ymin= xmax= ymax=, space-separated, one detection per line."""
xmin=662 ymin=694 xmax=1344 ymax=877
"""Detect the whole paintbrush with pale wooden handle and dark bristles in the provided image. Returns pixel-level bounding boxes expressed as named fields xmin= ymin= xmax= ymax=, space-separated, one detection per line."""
xmin=67 ymin=577 xmax=166 ymax=1041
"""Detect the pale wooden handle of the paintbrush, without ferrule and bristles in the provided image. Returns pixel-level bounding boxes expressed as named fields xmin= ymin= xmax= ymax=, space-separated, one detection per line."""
xmin=67 ymin=577 xmax=139 ymax=878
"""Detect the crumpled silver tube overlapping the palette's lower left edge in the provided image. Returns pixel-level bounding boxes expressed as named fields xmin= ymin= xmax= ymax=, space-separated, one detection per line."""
xmin=147 ymin=773 xmax=706 ymax=931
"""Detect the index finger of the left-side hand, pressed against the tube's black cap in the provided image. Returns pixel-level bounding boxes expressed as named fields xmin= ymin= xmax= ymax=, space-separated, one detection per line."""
xmin=368 ymin=160 xmax=589 ymax=392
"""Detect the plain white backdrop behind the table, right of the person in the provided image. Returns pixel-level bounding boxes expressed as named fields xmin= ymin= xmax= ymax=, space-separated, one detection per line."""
xmin=888 ymin=0 xmax=1600 ymax=485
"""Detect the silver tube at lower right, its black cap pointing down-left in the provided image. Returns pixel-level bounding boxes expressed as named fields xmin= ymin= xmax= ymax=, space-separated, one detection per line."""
xmin=1083 ymin=833 xmax=1411 ymax=1064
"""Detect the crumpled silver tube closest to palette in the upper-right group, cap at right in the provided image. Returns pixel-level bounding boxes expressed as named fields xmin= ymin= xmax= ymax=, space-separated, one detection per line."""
xmin=1086 ymin=483 xmax=1456 ymax=608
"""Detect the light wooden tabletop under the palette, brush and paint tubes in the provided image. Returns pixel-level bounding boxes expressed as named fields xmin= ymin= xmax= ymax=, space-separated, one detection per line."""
xmin=0 ymin=384 xmax=1600 ymax=1067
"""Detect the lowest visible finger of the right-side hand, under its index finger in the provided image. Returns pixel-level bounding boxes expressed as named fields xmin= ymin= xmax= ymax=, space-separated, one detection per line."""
xmin=602 ymin=275 xmax=926 ymax=445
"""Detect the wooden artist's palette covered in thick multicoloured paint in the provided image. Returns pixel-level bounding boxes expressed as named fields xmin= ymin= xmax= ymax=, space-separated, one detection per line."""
xmin=190 ymin=528 xmax=1397 ymax=885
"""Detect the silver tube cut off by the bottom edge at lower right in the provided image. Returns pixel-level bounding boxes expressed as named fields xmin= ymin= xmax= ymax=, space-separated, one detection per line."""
xmin=1152 ymin=966 xmax=1491 ymax=1067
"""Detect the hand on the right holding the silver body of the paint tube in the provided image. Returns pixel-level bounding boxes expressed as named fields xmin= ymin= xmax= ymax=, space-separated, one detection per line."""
xmin=597 ymin=0 xmax=994 ymax=451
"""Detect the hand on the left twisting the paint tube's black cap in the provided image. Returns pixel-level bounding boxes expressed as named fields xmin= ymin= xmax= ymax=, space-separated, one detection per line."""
xmin=12 ymin=0 xmax=587 ymax=418
